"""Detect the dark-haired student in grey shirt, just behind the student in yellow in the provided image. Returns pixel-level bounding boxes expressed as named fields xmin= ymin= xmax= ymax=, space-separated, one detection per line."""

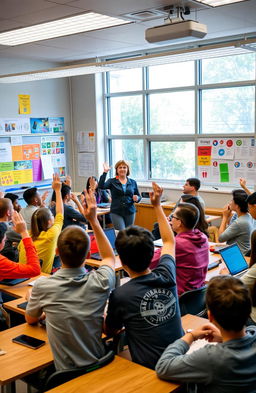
xmin=20 ymin=187 xmax=48 ymax=230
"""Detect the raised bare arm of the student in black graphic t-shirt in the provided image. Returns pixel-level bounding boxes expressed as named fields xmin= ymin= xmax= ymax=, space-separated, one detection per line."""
xmin=150 ymin=182 xmax=175 ymax=257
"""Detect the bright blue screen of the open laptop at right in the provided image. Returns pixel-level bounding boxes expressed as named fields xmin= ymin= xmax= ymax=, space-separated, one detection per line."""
xmin=219 ymin=243 xmax=248 ymax=277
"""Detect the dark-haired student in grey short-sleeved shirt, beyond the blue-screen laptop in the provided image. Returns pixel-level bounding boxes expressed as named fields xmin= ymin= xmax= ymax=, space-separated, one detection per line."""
xmin=219 ymin=190 xmax=253 ymax=254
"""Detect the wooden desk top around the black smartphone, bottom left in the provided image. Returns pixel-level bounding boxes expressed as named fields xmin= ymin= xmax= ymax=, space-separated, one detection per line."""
xmin=0 ymin=323 xmax=53 ymax=385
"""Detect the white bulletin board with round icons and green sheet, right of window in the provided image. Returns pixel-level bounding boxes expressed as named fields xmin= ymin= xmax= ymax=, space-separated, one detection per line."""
xmin=197 ymin=137 xmax=256 ymax=186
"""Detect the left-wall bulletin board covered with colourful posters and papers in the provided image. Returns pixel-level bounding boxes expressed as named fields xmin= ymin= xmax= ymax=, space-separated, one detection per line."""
xmin=0 ymin=117 xmax=67 ymax=190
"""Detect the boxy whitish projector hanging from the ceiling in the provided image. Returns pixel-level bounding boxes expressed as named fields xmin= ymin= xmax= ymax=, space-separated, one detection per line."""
xmin=145 ymin=20 xmax=207 ymax=42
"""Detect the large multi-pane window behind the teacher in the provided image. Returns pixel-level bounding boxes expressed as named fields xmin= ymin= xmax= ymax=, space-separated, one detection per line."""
xmin=105 ymin=52 xmax=256 ymax=182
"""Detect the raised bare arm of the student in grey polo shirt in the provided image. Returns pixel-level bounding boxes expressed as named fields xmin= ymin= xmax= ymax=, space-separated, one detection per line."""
xmin=84 ymin=190 xmax=115 ymax=270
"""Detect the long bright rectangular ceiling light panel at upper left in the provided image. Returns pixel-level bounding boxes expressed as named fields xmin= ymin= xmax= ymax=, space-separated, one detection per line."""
xmin=0 ymin=12 xmax=132 ymax=46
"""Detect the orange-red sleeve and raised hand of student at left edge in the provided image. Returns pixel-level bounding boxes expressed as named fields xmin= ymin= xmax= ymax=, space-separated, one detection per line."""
xmin=0 ymin=212 xmax=41 ymax=280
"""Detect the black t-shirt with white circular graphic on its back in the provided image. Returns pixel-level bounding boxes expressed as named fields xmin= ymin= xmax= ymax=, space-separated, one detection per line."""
xmin=106 ymin=254 xmax=183 ymax=369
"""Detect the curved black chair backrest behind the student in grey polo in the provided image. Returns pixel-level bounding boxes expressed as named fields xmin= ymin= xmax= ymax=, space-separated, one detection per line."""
xmin=42 ymin=351 xmax=115 ymax=392
